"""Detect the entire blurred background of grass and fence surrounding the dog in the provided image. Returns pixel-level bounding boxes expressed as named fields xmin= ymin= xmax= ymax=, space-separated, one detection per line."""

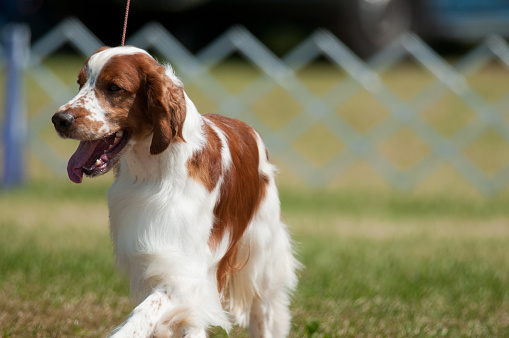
xmin=0 ymin=0 xmax=509 ymax=337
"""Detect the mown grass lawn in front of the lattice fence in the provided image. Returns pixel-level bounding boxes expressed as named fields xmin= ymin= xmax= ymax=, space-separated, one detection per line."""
xmin=0 ymin=177 xmax=509 ymax=337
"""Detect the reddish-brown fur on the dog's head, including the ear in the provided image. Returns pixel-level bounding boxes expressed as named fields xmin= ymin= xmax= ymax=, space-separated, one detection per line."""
xmin=58 ymin=51 xmax=186 ymax=154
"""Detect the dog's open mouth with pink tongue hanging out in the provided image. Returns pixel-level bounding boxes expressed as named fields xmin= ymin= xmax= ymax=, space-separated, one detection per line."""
xmin=67 ymin=130 xmax=128 ymax=183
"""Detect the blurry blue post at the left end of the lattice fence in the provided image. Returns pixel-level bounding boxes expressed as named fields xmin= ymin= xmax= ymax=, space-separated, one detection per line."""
xmin=2 ymin=24 xmax=30 ymax=188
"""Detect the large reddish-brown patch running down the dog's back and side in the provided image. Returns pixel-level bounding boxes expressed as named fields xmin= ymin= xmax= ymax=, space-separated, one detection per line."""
xmin=206 ymin=115 xmax=268 ymax=291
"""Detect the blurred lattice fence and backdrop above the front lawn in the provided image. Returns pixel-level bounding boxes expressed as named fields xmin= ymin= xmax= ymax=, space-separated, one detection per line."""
xmin=0 ymin=0 xmax=509 ymax=195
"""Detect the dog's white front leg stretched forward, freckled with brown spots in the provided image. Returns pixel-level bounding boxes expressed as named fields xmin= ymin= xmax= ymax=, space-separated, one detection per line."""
xmin=110 ymin=289 xmax=173 ymax=338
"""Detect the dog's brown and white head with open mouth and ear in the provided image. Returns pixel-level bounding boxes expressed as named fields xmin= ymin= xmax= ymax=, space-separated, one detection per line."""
xmin=51 ymin=47 xmax=186 ymax=183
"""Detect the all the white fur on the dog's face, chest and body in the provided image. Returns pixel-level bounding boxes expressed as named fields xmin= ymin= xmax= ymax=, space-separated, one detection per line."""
xmin=64 ymin=48 xmax=298 ymax=338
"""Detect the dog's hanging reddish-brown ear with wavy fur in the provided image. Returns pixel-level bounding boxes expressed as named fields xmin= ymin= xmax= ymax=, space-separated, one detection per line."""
xmin=146 ymin=66 xmax=186 ymax=155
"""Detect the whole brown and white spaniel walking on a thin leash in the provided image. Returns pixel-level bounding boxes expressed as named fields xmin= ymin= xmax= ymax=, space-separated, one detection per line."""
xmin=52 ymin=47 xmax=299 ymax=337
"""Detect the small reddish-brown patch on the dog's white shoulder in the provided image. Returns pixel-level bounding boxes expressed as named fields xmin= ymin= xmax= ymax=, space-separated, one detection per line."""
xmin=187 ymin=119 xmax=222 ymax=192
